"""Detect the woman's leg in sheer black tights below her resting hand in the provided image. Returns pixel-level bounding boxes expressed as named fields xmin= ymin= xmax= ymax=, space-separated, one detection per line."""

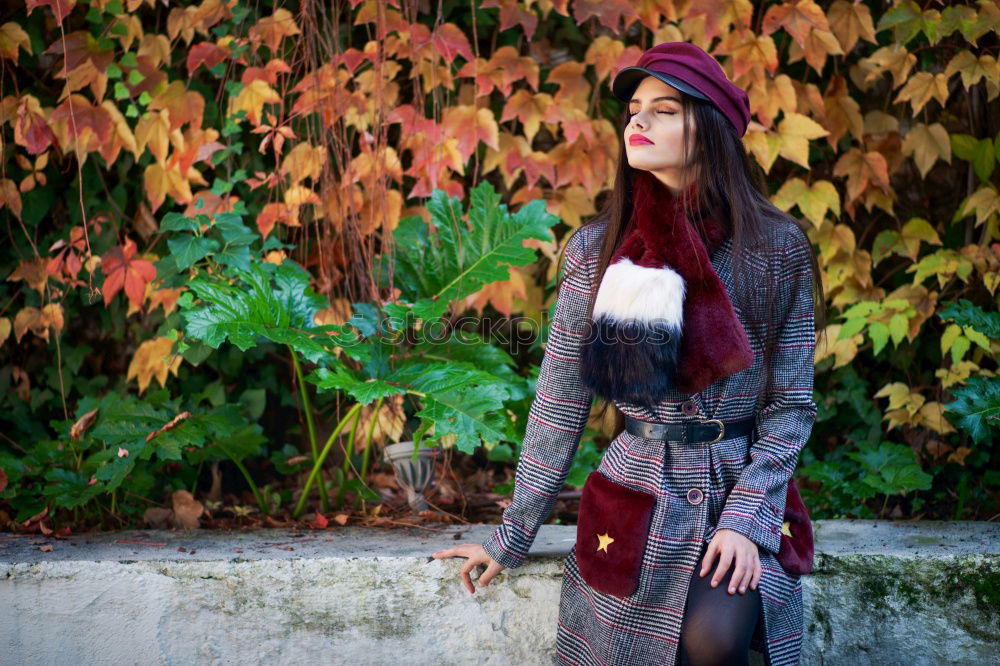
xmin=679 ymin=543 xmax=767 ymax=666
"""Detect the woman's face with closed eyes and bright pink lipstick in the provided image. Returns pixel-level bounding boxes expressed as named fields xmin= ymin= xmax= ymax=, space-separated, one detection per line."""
xmin=623 ymin=76 xmax=695 ymax=191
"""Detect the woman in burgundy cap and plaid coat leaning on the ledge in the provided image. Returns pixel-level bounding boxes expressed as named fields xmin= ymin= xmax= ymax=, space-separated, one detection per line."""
xmin=434 ymin=42 xmax=824 ymax=666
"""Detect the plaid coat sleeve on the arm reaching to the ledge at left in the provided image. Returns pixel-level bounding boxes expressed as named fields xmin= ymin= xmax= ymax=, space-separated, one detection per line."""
xmin=483 ymin=231 xmax=593 ymax=569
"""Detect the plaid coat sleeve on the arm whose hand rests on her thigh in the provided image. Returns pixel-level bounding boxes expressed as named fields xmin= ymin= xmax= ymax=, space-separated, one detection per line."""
xmin=716 ymin=227 xmax=816 ymax=554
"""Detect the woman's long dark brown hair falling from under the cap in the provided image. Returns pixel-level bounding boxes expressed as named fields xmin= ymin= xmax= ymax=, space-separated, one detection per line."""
xmin=557 ymin=85 xmax=826 ymax=434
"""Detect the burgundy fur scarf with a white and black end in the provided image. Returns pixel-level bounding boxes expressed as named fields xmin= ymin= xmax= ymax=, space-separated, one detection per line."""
xmin=580 ymin=171 xmax=754 ymax=407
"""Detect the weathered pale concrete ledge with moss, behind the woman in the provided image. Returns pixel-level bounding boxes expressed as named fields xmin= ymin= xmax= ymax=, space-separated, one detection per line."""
xmin=0 ymin=520 xmax=1000 ymax=666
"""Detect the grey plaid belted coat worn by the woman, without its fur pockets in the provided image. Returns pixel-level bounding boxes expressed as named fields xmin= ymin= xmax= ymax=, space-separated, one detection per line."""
xmin=483 ymin=219 xmax=816 ymax=666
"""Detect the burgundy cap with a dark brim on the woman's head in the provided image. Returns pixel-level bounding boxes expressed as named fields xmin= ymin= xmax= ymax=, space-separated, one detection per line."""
xmin=611 ymin=42 xmax=750 ymax=136
